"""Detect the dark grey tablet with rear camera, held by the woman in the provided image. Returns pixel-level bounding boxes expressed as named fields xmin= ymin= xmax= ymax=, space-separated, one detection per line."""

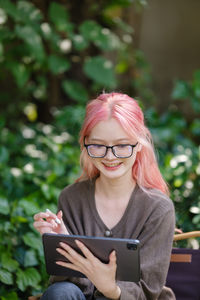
xmin=42 ymin=233 xmax=140 ymax=282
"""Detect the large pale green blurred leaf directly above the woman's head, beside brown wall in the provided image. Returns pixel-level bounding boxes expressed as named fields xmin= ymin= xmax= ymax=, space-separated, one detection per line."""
xmin=83 ymin=56 xmax=116 ymax=88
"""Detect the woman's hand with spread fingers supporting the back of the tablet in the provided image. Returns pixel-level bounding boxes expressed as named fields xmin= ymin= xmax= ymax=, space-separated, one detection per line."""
xmin=56 ymin=240 xmax=121 ymax=299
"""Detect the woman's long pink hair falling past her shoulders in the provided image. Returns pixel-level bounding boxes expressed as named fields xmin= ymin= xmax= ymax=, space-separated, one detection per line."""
xmin=77 ymin=93 xmax=169 ymax=194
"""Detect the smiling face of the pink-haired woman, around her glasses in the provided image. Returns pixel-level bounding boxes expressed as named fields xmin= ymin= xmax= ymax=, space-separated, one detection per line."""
xmin=85 ymin=118 xmax=140 ymax=179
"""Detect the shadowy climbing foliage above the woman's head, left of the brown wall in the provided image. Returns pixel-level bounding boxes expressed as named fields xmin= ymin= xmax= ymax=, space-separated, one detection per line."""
xmin=0 ymin=0 xmax=145 ymax=123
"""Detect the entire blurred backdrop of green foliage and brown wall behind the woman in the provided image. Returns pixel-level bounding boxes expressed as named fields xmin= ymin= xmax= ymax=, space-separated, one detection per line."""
xmin=0 ymin=0 xmax=200 ymax=300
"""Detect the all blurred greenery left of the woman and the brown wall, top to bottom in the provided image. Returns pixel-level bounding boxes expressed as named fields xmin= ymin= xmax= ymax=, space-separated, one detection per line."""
xmin=0 ymin=0 xmax=148 ymax=300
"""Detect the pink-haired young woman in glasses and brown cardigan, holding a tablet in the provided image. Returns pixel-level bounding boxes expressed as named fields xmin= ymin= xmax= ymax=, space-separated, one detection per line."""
xmin=34 ymin=93 xmax=175 ymax=300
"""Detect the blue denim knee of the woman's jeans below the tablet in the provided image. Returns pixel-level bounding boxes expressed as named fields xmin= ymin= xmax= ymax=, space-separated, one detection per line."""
xmin=40 ymin=282 xmax=86 ymax=300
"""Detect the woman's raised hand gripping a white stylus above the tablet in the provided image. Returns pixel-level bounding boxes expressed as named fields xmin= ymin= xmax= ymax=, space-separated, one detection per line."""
xmin=33 ymin=209 xmax=69 ymax=235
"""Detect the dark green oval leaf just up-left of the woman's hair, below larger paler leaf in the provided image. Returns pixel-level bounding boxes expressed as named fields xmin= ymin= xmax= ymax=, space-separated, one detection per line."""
xmin=62 ymin=80 xmax=89 ymax=103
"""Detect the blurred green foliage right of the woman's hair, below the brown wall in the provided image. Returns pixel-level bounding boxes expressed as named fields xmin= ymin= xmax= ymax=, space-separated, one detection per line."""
xmin=146 ymin=71 xmax=200 ymax=237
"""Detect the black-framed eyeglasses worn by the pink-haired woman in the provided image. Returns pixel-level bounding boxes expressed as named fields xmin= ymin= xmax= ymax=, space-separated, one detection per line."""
xmin=84 ymin=142 xmax=138 ymax=158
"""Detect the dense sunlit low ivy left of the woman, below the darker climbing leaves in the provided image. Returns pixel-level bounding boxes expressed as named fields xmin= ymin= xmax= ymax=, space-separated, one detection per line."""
xmin=0 ymin=117 xmax=81 ymax=299
